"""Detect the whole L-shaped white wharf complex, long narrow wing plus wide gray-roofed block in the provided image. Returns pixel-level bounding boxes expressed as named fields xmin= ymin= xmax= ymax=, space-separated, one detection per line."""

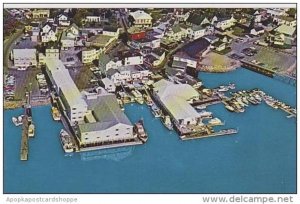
xmin=45 ymin=58 xmax=141 ymax=149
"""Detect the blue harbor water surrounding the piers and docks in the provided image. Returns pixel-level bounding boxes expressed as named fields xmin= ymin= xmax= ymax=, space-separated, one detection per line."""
xmin=4 ymin=69 xmax=296 ymax=193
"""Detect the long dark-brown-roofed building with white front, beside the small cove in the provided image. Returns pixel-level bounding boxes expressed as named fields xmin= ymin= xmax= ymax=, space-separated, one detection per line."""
xmin=173 ymin=38 xmax=210 ymax=68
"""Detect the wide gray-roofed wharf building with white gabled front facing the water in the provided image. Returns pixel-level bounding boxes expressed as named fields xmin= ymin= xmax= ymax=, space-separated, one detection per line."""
xmin=75 ymin=89 xmax=137 ymax=149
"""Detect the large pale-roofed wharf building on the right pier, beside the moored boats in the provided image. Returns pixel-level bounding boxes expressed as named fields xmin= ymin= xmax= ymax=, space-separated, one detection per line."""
xmin=153 ymin=79 xmax=201 ymax=126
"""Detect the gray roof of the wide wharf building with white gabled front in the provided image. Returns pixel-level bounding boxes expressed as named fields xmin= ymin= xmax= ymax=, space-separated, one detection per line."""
xmin=79 ymin=94 xmax=132 ymax=132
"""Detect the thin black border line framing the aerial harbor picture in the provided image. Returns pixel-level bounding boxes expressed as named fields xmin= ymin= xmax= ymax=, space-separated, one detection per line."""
xmin=1 ymin=2 xmax=299 ymax=195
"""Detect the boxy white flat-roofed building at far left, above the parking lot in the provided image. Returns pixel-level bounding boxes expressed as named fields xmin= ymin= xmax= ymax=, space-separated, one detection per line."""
xmin=11 ymin=49 xmax=37 ymax=68
